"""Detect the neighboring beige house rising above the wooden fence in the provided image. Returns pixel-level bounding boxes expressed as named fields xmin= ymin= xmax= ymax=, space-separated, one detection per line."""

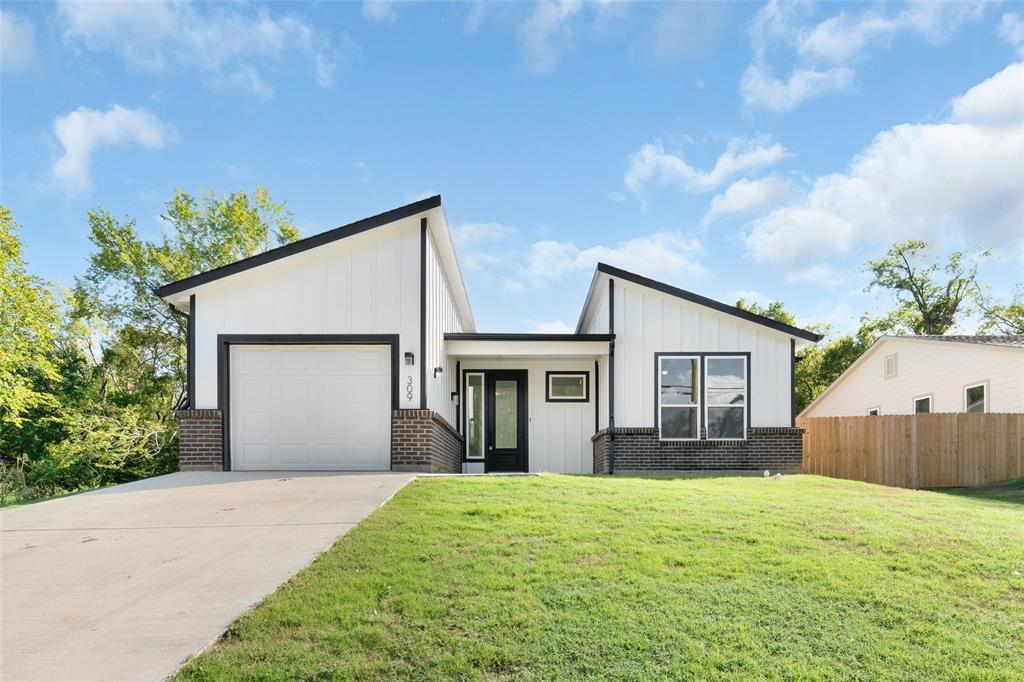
xmin=800 ymin=336 xmax=1024 ymax=417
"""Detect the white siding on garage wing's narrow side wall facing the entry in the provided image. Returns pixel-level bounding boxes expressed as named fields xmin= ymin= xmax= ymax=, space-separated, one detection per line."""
xmin=424 ymin=225 xmax=463 ymax=425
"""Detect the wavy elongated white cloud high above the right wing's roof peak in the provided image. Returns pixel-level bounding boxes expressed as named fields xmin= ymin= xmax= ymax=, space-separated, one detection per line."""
xmin=623 ymin=138 xmax=785 ymax=197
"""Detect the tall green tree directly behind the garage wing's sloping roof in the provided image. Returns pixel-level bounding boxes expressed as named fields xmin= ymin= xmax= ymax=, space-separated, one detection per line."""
xmin=75 ymin=187 xmax=299 ymax=409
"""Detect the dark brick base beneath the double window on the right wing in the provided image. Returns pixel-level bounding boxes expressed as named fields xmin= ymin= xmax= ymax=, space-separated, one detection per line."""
xmin=591 ymin=427 xmax=804 ymax=473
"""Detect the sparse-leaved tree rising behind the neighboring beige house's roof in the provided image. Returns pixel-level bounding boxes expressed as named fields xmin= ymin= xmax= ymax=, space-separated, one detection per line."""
xmin=864 ymin=240 xmax=989 ymax=335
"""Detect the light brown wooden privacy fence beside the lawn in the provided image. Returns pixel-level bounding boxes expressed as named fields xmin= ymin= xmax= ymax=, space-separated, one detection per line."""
xmin=797 ymin=413 xmax=1024 ymax=488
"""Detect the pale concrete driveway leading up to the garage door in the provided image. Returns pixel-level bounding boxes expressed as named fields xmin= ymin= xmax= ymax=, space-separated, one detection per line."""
xmin=0 ymin=472 xmax=414 ymax=682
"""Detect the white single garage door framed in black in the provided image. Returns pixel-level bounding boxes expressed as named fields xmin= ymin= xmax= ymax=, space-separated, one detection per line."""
xmin=229 ymin=345 xmax=391 ymax=471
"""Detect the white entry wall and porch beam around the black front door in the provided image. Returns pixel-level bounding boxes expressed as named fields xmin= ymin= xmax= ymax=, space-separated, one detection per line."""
xmin=462 ymin=356 xmax=605 ymax=473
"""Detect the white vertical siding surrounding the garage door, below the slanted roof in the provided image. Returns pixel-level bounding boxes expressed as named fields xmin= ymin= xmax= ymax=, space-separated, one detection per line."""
xmin=196 ymin=217 xmax=422 ymax=409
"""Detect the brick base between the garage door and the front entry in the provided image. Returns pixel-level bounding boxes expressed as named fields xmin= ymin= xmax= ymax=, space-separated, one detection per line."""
xmin=391 ymin=410 xmax=463 ymax=473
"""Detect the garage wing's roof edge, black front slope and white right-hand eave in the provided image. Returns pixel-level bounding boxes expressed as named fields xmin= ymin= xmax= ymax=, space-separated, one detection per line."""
xmin=156 ymin=195 xmax=474 ymax=329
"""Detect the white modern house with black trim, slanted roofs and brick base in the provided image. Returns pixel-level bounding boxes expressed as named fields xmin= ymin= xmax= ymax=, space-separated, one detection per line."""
xmin=158 ymin=197 xmax=818 ymax=473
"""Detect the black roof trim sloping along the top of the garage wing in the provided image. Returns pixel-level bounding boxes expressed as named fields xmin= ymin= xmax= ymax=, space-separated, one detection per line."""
xmin=156 ymin=195 xmax=441 ymax=297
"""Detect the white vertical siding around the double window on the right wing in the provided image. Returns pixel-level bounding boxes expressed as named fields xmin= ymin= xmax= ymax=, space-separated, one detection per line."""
xmin=614 ymin=280 xmax=792 ymax=427
